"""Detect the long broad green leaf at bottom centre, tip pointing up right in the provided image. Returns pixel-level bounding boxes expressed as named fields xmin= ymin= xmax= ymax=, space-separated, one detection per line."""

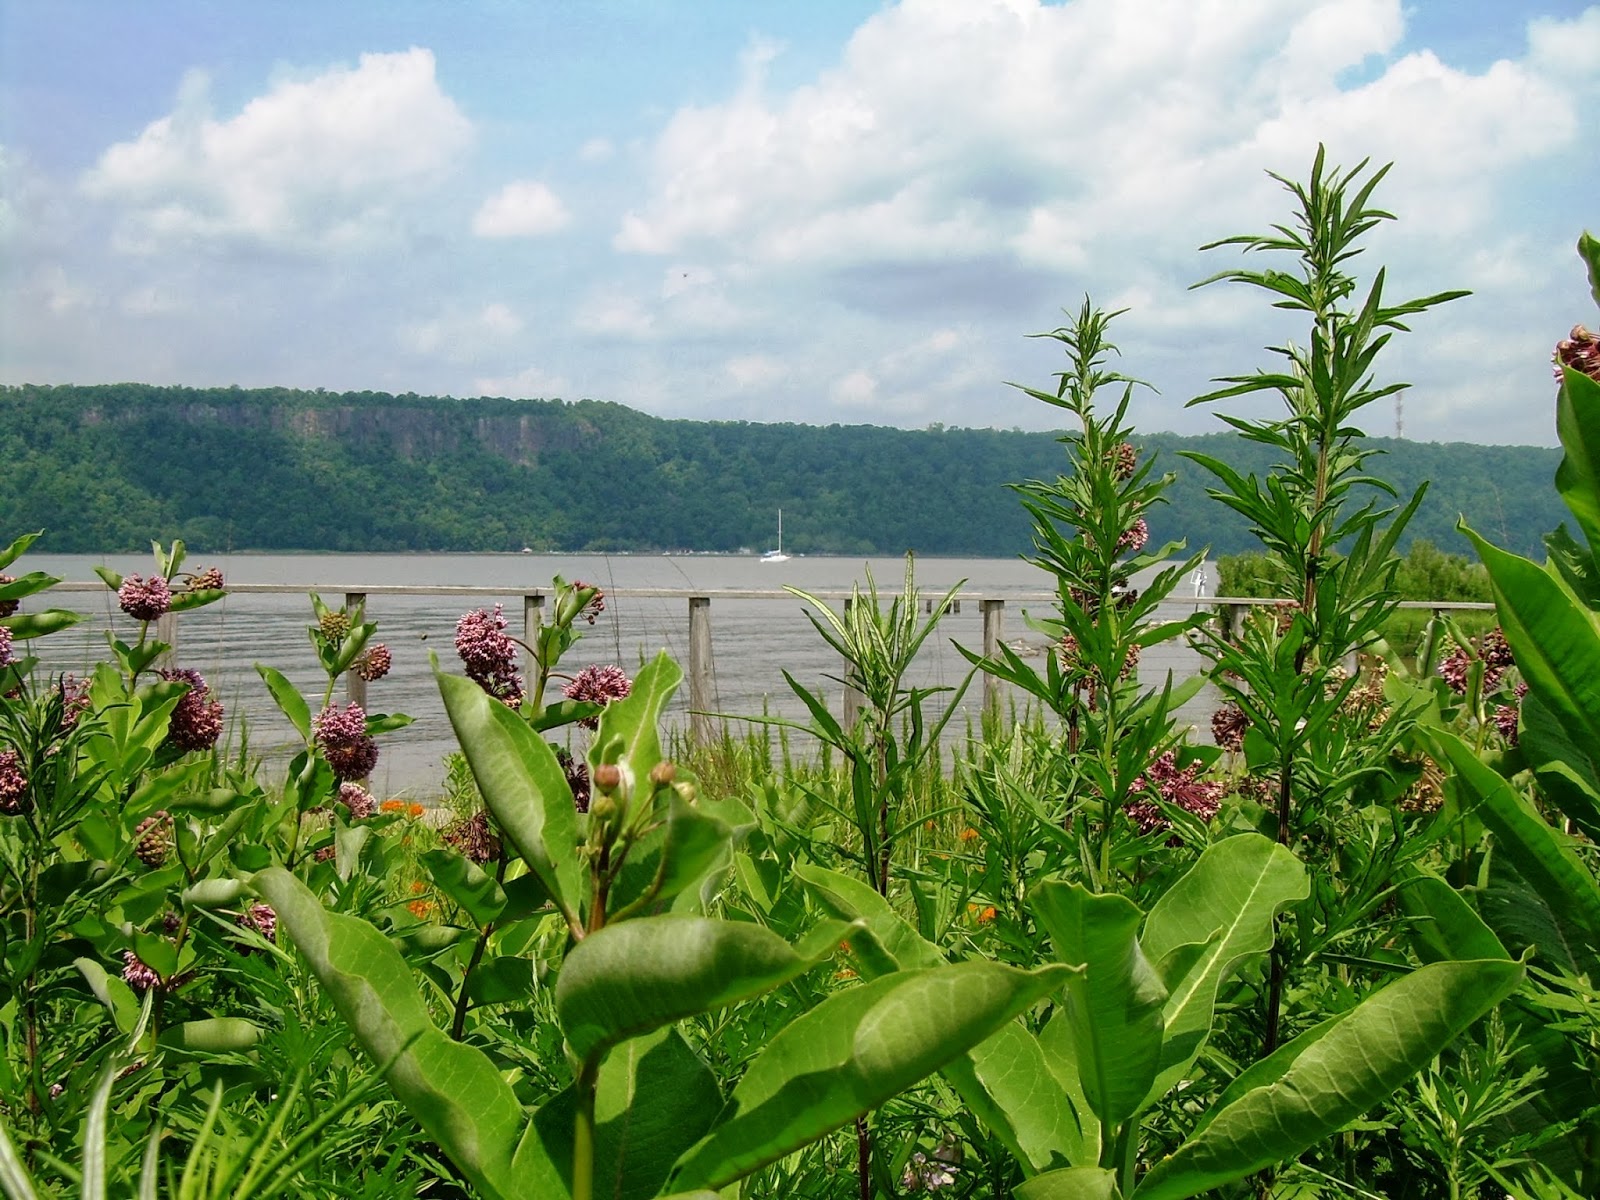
xmin=670 ymin=962 xmax=1072 ymax=1190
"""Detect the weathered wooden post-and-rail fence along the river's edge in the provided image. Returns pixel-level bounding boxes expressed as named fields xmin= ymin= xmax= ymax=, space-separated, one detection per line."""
xmin=51 ymin=581 xmax=1494 ymax=744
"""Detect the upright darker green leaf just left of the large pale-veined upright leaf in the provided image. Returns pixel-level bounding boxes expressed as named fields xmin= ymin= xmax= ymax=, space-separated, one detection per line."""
xmin=1029 ymin=883 xmax=1166 ymax=1126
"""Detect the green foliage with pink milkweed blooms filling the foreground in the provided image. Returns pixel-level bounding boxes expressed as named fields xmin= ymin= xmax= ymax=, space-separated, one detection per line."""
xmin=0 ymin=155 xmax=1600 ymax=1200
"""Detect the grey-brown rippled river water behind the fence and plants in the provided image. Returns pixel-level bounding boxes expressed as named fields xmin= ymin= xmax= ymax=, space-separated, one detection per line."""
xmin=8 ymin=554 xmax=1216 ymax=797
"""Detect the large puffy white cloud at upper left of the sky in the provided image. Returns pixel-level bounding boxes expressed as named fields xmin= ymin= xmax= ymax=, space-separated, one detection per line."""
xmin=82 ymin=48 xmax=472 ymax=253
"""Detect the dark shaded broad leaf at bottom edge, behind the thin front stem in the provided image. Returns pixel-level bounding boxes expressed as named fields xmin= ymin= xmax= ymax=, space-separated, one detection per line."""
xmin=533 ymin=1029 xmax=722 ymax=1200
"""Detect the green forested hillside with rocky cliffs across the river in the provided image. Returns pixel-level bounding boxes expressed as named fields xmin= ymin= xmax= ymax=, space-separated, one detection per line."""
xmin=0 ymin=384 xmax=1562 ymax=555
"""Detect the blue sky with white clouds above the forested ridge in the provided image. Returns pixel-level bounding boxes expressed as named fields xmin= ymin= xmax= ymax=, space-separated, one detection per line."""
xmin=0 ymin=0 xmax=1600 ymax=445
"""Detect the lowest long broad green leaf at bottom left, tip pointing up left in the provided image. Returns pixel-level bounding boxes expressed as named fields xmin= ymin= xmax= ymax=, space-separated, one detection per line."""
xmin=251 ymin=867 xmax=534 ymax=1200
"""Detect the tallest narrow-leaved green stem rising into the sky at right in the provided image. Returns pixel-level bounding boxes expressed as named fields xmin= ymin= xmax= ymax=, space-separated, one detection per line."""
xmin=1186 ymin=147 xmax=1466 ymax=1053
